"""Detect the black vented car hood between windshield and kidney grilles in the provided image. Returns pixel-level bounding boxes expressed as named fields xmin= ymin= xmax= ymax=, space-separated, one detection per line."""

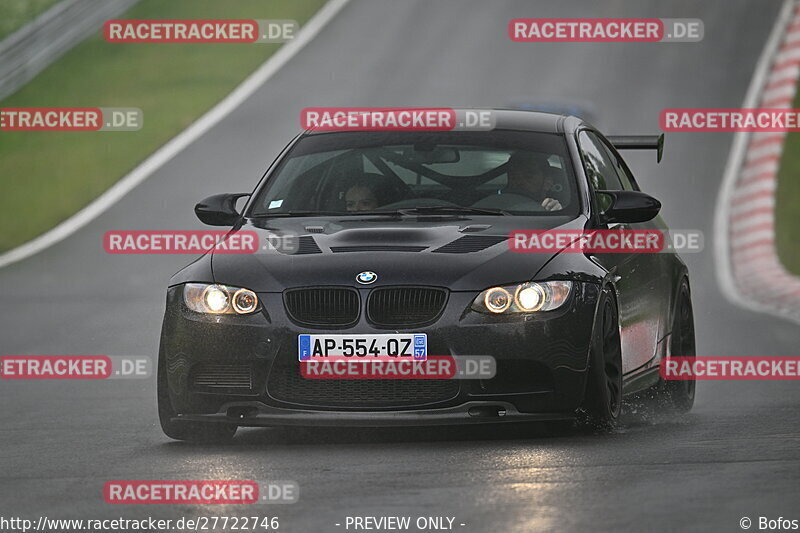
xmin=211 ymin=216 xmax=586 ymax=292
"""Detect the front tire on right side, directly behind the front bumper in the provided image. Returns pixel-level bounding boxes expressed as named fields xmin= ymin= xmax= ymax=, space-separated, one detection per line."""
xmin=581 ymin=288 xmax=622 ymax=430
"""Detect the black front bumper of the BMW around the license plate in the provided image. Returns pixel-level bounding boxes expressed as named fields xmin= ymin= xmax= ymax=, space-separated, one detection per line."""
xmin=159 ymin=282 xmax=599 ymax=426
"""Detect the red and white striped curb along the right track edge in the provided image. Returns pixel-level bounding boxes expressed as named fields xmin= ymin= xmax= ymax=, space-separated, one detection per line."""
xmin=714 ymin=0 xmax=800 ymax=322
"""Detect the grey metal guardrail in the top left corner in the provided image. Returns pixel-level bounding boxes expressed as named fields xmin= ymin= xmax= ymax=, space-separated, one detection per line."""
xmin=0 ymin=0 xmax=139 ymax=100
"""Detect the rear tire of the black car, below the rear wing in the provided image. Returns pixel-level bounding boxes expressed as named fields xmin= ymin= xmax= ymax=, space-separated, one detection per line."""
xmin=661 ymin=278 xmax=696 ymax=413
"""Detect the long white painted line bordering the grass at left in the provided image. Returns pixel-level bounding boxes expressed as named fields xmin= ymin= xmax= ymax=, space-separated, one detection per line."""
xmin=0 ymin=0 xmax=349 ymax=268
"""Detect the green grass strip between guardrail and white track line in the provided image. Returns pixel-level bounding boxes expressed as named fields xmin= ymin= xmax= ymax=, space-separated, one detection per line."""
xmin=0 ymin=0 xmax=325 ymax=253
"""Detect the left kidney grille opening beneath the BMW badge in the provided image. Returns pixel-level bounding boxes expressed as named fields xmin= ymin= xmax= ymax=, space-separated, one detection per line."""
xmin=283 ymin=287 xmax=360 ymax=328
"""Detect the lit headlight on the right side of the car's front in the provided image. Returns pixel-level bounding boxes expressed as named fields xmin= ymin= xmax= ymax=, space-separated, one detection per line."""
xmin=472 ymin=281 xmax=572 ymax=314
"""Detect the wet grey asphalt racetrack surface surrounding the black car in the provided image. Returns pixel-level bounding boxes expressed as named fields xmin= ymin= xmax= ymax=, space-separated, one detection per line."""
xmin=0 ymin=0 xmax=800 ymax=533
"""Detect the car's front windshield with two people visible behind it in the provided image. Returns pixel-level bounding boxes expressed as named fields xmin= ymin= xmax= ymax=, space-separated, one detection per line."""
xmin=248 ymin=131 xmax=579 ymax=217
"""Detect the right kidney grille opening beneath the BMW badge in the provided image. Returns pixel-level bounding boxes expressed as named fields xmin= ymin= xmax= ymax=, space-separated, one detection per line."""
xmin=367 ymin=287 xmax=447 ymax=328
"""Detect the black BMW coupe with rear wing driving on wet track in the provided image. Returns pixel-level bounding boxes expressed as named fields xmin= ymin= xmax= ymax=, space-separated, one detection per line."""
xmin=158 ymin=110 xmax=694 ymax=440
